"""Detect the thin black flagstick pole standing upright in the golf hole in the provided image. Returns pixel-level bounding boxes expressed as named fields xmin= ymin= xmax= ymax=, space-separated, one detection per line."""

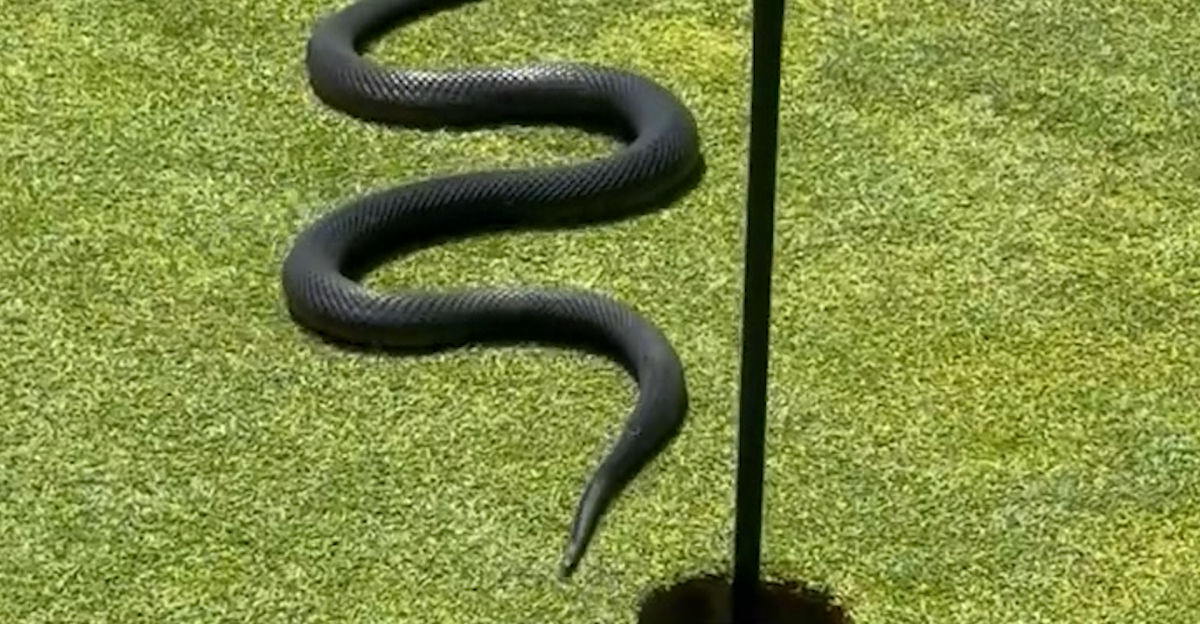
xmin=733 ymin=0 xmax=784 ymax=624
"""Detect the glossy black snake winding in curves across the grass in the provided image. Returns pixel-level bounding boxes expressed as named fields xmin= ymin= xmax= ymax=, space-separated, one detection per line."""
xmin=282 ymin=0 xmax=706 ymax=580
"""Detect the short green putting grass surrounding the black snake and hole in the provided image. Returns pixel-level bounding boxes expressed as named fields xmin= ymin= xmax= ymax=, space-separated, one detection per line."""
xmin=0 ymin=0 xmax=1200 ymax=624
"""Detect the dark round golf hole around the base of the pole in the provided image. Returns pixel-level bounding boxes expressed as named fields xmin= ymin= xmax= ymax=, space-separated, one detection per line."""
xmin=637 ymin=575 xmax=853 ymax=624
